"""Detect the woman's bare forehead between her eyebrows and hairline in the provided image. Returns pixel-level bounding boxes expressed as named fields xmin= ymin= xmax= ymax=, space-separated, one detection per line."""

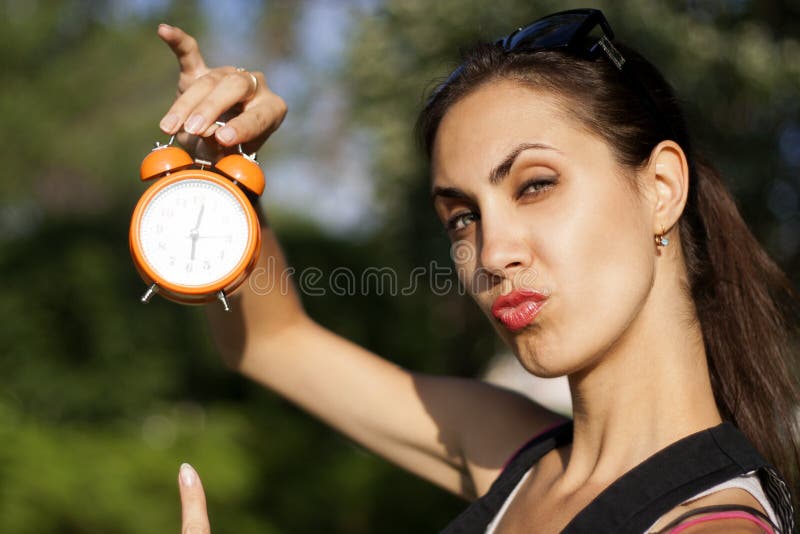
xmin=432 ymin=80 xmax=607 ymax=184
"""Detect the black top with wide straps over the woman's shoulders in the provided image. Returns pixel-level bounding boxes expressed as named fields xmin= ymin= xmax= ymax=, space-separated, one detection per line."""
xmin=442 ymin=421 xmax=795 ymax=534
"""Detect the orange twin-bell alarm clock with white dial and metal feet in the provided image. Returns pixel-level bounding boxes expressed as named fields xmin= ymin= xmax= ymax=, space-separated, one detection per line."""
xmin=129 ymin=131 xmax=264 ymax=311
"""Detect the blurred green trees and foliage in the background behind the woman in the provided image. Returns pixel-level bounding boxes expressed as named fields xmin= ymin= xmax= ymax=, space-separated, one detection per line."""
xmin=0 ymin=0 xmax=800 ymax=534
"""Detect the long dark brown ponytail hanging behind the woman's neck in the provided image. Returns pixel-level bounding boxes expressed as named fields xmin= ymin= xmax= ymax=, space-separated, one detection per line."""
xmin=679 ymin=160 xmax=800 ymax=508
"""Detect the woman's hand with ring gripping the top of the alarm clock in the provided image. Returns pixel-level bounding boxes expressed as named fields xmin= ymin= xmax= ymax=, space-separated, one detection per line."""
xmin=158 ymin=24 xmax=286 ymax=158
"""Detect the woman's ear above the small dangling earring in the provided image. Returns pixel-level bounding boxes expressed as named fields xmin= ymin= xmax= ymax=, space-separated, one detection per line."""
xmin=645 ymin=141 xmax=689 ymax=234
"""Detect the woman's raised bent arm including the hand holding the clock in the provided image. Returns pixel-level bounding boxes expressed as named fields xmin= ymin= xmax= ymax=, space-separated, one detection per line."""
xmin=159 ymin=27 xmax=563 ymax=498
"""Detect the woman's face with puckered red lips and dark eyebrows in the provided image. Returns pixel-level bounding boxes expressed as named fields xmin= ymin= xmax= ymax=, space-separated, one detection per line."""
xmin=432 ymin=81 xmax=655 ymax=382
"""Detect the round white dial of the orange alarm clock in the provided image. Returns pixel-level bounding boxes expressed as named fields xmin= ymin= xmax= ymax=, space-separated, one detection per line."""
xmin=139 ymin=179 xmax=249 ymax=286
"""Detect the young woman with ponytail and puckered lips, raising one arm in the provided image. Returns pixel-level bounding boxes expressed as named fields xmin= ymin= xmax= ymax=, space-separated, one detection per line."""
xmin=159 ymin=10 xmax=800 ymax=533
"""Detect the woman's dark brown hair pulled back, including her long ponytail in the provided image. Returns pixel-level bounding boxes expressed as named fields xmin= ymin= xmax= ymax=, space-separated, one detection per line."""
xmin=417 ymin=42 xmax=800 ymax=510
